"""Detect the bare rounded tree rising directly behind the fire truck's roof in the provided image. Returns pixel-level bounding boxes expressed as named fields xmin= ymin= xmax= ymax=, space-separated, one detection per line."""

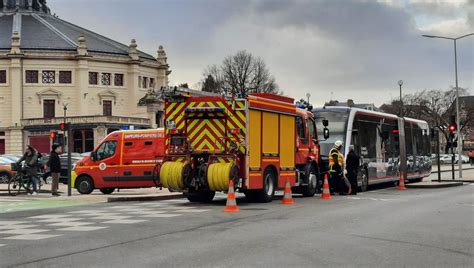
xmin=202 ymin=50 xmax=279 ymax=97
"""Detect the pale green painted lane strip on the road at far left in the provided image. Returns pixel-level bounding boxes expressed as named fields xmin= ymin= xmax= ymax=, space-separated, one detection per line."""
xmin=0 ymin=198 xmax=95 ymax=213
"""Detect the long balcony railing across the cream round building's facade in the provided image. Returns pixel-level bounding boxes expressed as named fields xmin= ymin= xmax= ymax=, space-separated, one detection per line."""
xmin=21 ymin=115 xmax=150 ymax=127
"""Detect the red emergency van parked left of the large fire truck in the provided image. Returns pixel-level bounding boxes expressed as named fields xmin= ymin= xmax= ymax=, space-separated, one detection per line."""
xmin=71 ymin=129 xmax=165 ymax=194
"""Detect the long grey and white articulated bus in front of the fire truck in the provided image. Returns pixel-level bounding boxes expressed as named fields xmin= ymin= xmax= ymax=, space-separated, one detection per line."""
xmin=313 ymin=107 xmax=431 ymax=191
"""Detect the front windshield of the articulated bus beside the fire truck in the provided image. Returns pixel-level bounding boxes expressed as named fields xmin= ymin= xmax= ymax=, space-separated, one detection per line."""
xmin=316 ymin=111 xmax=349 ymax=155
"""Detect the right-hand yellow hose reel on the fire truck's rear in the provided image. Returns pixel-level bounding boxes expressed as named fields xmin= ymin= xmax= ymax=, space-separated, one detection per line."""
xmin=207 ymin=162 xmax=239 ymax=191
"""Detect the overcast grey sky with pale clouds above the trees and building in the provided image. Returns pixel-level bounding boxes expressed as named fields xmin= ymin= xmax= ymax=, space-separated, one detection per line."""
xmin=48 ymin=0 xmax=474 ymax=105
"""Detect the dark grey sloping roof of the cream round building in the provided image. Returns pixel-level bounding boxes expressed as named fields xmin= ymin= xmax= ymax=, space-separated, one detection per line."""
xmin=0 ymin=0 xmax=156 ymax=61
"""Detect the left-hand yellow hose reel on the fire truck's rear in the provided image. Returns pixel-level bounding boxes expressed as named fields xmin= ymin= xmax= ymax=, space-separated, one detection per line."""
xmin=160 ymin=162 xmax=191 ymax=190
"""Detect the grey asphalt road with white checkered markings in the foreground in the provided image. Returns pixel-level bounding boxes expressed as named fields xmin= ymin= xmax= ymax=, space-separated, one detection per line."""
xmin=0 ymin=184 xmax=474 ymax=267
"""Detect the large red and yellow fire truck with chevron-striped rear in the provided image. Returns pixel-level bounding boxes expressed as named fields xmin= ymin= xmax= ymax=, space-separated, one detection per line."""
xmin=158 ymin=93 xmax=329 ymax=202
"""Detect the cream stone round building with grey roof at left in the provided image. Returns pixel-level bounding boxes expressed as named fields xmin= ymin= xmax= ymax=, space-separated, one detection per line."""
xmin=0 ymin=0 xmax=170 ymax=154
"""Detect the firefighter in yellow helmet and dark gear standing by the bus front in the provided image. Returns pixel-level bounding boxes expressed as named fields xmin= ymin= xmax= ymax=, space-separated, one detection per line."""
xmin=329 ymin=141 xmax=351 ymax=194
